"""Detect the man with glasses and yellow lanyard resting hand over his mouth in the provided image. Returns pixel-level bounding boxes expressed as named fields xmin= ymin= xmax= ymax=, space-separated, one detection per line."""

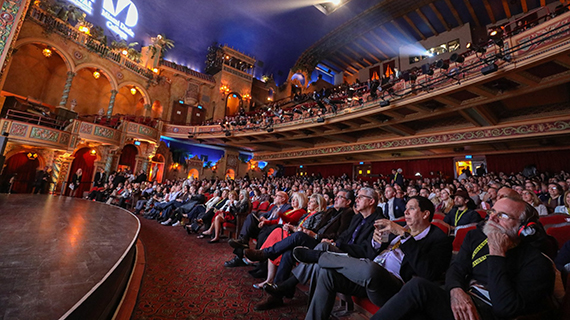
xmin=372 ymin=198 xmax=555 ymax=320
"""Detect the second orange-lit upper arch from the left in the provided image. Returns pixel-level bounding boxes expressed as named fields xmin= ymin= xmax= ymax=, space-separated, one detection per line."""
xmin=68 ymin=67 xmax=112 ymax=115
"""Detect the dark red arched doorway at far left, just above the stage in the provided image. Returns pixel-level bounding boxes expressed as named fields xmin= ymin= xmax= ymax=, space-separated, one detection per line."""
xmin=0 ymin=152 xmax=40 ymax=193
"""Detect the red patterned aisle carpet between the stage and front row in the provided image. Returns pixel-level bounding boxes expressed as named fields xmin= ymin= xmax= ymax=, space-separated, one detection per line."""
xmin=132 ymin=218 xmax=307 ymax=320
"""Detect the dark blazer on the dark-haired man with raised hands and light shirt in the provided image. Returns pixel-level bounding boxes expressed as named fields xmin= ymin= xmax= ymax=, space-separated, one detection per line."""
xmin=377 ymin=225 xmax=453 ymax=282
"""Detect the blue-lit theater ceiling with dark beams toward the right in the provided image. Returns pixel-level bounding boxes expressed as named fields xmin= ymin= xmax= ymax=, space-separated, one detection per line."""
xmin=75 ymin=0 xmax=558 ymax=84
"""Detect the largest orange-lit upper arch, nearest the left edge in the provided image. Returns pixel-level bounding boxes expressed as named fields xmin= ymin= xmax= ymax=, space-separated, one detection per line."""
xmin=2 ymin=43 xmax=68 ymax=106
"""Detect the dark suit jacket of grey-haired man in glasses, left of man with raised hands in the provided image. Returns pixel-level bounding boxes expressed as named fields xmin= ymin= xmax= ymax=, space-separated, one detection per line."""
xmin=336 ymin=210 xmax=383 ymax=258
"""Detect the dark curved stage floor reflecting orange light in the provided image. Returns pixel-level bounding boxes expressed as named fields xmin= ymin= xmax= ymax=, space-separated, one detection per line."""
xmin=0 ymin=194 xmax=140 ymax=320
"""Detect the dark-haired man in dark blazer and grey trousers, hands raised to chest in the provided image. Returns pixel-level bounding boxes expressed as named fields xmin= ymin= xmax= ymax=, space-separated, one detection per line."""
xmin=293 ymin=196 xmax=452 ymax=319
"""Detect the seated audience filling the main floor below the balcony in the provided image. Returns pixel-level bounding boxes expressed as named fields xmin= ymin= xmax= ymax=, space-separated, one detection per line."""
xmin=75 ymin=161 xmax=570 ymax=319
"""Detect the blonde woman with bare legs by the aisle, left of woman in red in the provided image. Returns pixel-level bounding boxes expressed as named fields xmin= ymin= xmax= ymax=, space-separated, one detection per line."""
xmin=198 ymin=189 xmax=251 ymax=243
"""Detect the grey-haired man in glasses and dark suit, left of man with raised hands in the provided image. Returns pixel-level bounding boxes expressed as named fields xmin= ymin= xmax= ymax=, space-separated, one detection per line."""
xmin=255 ymin=188 xmax=382 ymax=310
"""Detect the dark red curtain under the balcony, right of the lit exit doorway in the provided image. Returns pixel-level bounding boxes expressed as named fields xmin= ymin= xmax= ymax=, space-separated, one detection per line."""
xmin=487 ymin=150 xmax=570 ymax=174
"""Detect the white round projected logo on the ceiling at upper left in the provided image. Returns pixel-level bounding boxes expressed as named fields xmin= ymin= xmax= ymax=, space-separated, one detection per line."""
xmin=101 ymin=0 xmax=139 ymax=40
